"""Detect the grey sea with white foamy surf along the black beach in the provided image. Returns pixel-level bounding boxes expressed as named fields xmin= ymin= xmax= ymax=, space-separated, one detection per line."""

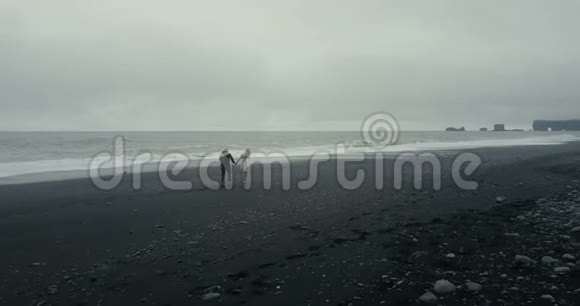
xmin=0 ymin=131 xmax=580 ymax=184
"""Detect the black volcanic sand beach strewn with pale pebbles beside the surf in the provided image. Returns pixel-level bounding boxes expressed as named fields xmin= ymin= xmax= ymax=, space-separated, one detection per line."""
xmin=0 ymin=143 xmax=580 ymax=305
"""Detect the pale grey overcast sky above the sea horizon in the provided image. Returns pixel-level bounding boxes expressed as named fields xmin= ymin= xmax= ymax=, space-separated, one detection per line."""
xmin=0 ymin=0 xmax=580 ymax=130
